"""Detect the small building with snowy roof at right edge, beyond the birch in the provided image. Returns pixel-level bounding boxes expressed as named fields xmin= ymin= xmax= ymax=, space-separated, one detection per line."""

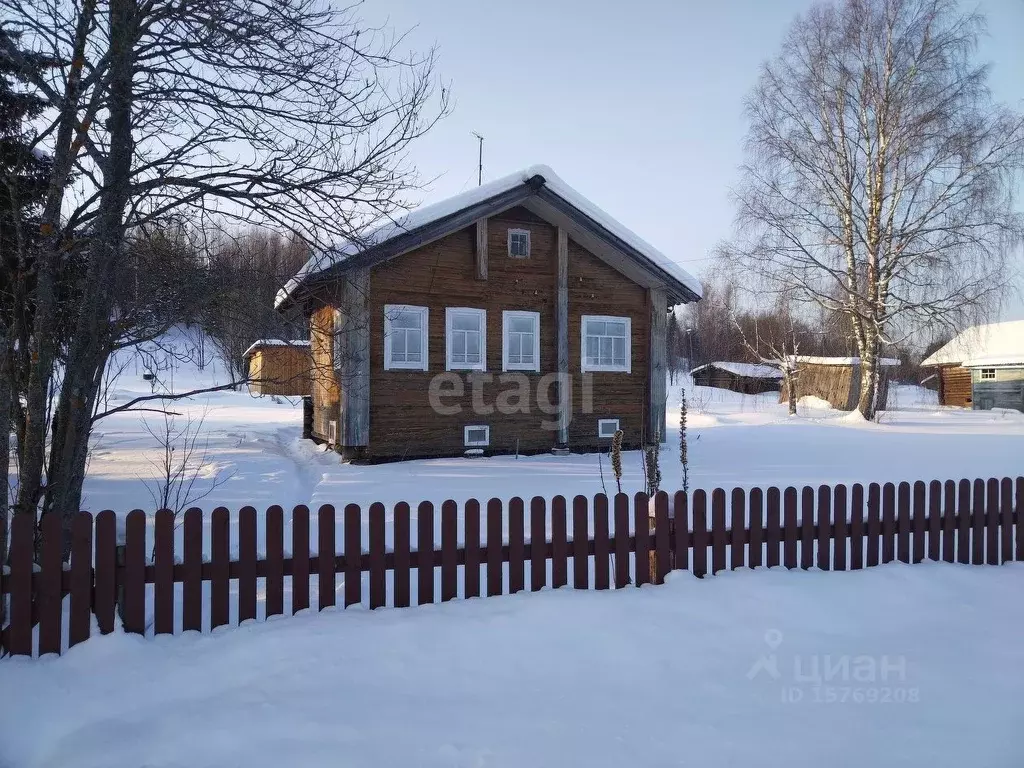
xmin=921 ymin=321 xmax=1024 ymax=411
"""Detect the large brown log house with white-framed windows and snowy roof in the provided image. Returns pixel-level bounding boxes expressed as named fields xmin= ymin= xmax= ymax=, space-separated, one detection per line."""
xmin=276 ymin=166 xmax=700 ymax=461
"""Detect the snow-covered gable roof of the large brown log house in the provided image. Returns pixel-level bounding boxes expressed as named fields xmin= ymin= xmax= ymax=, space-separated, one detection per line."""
xmin=274 ymin=165 xmax=700 ymax=308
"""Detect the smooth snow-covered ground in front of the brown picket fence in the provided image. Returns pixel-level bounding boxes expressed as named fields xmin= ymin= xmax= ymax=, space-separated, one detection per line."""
xmin=0 ymin=563 xmax=1024 ymax=768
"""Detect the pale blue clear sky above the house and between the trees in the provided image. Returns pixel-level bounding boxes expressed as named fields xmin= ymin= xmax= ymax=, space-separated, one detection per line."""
xmin=359 ymin=0 xmax=1024 ymax=319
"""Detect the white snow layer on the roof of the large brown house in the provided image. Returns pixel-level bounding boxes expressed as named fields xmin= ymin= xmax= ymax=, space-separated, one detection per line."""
xmin=274 ymin=165 xmax=700 ymax=307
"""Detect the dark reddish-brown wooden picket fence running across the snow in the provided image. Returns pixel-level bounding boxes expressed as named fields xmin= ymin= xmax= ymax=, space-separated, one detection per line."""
xmin=0 ymin=477 xmax=1024 ymax=655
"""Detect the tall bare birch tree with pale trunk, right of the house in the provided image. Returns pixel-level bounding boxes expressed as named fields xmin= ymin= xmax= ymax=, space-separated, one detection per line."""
xmin=725 ymin=0 xmax=1024 ymax=418
